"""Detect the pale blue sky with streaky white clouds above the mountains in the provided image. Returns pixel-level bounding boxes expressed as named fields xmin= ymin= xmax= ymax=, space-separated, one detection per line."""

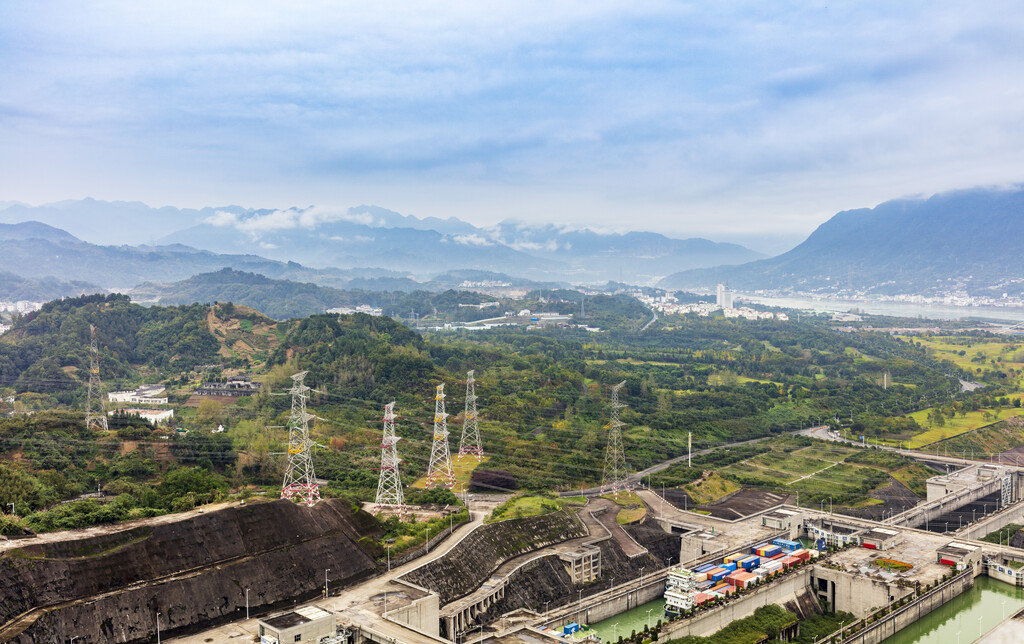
xmin=0 ymin=0 xmax=1024 ymax=246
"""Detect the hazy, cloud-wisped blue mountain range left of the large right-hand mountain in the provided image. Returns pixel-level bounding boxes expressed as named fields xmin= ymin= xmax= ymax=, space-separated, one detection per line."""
xmin=0 ymin=200 xmax=762 ymax=289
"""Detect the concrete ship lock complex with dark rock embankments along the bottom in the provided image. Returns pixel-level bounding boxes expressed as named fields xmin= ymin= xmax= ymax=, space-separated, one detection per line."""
xmin=9 ymin=460 xmax=1024 ymax=644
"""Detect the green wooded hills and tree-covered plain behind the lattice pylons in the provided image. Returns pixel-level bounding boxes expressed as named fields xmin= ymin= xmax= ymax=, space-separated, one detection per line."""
xmin=0 ymin=293 xmax=1006 ymax=527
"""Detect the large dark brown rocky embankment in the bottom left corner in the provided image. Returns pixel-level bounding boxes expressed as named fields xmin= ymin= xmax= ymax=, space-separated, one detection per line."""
xmin=0 ymin=500 xmax=379 ymax=644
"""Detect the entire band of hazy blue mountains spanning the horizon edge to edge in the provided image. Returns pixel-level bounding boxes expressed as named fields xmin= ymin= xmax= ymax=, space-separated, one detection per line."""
xmin=0 ymin=188 xmax=1024 ymax=299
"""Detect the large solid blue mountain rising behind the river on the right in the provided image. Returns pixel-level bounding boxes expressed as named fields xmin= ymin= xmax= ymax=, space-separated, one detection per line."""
xmin=659 ymin=188 xmax=1024 ymax=296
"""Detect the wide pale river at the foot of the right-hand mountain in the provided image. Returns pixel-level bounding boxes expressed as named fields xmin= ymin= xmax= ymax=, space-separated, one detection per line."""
xmin=738 ymin=294 xmax=1024 ymax=321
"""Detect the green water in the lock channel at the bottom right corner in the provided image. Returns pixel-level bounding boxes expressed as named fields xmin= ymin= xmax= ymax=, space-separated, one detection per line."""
xmin=882 ymin=575 xmax=1024 ymax=644
